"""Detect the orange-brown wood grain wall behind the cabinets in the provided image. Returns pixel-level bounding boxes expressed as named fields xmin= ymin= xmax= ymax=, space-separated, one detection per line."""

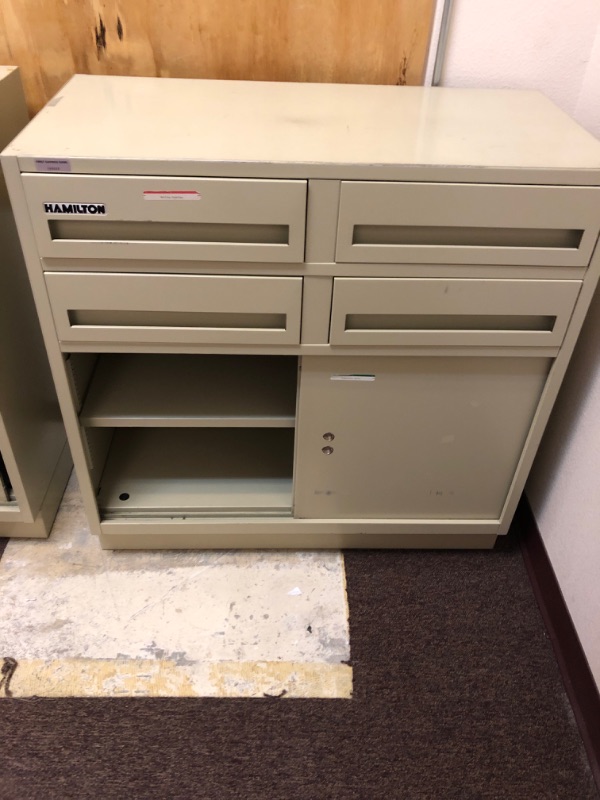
xmin=0 ymin=0 xmax=435 ymax=113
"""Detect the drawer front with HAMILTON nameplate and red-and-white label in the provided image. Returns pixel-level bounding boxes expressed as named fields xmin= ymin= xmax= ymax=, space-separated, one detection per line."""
xmin=23 ymin=174 xmax=306 ymax=262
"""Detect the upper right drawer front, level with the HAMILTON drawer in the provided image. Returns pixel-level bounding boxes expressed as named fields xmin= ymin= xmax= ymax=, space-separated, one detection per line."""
xmin=336 ymin=181 xmax=600 ymax=267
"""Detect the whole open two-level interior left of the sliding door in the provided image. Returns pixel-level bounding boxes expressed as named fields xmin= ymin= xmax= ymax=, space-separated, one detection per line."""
xmin=66 ymin=353 xmax=298 ymax=519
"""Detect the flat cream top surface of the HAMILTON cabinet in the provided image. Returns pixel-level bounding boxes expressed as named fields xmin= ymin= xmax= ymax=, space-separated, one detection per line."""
xmin=0 ymin=72 xmax=600 ymax=182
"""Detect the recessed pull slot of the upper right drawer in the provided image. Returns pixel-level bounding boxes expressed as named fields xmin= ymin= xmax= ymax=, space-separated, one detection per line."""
xmin=352 ymin=225 xmax=584 ymax=250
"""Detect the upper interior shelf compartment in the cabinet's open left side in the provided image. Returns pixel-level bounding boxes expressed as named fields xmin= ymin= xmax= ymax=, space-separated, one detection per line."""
xmin=80 ymin=353 xmax=298 ymax=428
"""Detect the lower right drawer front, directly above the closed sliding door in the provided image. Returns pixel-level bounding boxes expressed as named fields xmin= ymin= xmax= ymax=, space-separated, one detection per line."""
xmin=330 ymin=278 xmax=581 ymax=347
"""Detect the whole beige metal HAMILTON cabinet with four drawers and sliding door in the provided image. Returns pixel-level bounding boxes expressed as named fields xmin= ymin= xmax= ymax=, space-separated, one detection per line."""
xmin=3 ymin=76 xmax=600 ymax=548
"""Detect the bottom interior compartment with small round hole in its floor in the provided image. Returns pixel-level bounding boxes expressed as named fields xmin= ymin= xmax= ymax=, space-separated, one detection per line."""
xmin=98 ymin=428 xmax=294 ymax=519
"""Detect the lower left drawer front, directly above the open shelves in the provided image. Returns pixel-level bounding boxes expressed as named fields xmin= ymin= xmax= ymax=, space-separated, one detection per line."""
xmin=46 ymin=272 xmax=302 ymax=345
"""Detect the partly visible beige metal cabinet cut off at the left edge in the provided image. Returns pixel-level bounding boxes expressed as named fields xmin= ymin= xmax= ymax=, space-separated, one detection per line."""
xmin=0 ymin=67 xmax=71 ymax=537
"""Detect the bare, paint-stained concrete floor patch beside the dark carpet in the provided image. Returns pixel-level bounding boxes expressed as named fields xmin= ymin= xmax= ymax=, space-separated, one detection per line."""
xmin=0 ymin=481 xmax=352 ymax=697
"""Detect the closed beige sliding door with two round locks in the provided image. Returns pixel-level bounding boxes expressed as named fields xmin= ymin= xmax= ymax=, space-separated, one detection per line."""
xmin=294 ymin=357 xmax=551 ymax=520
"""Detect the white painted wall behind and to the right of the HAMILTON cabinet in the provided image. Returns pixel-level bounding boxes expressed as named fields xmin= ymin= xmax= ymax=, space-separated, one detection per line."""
xmin=441 ymin=0 xmax=600 ymax=687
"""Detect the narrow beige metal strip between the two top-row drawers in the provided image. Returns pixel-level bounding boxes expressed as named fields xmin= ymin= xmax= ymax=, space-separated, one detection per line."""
xmin=305 ymin=180 xmax=340 ymax=263
